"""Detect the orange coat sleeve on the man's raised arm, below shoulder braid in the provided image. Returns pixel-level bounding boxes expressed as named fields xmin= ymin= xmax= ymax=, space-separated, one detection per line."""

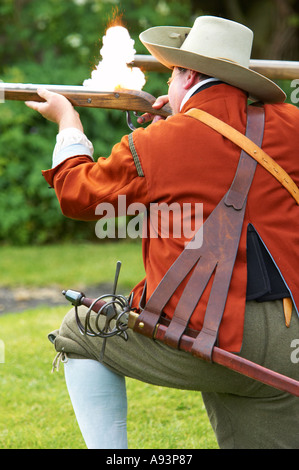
xmin=42 ymin=132 xmax=149 ymax=220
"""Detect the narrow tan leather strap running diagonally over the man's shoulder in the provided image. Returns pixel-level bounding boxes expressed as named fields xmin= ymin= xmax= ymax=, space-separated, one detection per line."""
xmin=185 ymin=108 xmax=299 ymax=204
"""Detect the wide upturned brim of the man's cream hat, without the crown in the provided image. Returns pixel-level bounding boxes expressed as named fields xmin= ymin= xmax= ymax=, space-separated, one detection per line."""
xmin=140 ymin=26 xmax=286 ymax=103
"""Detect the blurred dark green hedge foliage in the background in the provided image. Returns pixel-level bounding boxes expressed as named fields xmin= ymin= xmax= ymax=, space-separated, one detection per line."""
xmin=0 ymin=0 xmax=299 ymax=245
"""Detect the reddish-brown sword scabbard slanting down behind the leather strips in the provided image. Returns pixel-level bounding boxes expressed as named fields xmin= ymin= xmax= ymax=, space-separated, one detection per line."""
xmin=155 ymin=324 xmax=299 ymax=397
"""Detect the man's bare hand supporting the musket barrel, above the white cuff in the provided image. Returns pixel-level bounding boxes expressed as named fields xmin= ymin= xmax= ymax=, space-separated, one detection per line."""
xmin=25 ymin=88 xmax=83 ymax=132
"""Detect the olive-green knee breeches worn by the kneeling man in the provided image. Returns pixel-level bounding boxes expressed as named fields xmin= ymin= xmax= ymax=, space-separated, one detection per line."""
xmin=49 ymin=301 xmax=299 ymax=449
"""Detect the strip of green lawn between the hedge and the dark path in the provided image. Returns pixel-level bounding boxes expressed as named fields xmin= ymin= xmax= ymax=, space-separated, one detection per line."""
xmin=0 ymin=242 xmax=144 ymax=289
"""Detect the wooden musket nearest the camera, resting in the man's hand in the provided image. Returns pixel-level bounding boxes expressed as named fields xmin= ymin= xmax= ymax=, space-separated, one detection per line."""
xmin=0 ymin=82 xmax=172 ymax=123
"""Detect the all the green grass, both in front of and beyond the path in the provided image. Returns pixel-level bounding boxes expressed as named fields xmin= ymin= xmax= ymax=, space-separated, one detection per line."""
xmin=0 ymin=243 xmax=217 ymax=449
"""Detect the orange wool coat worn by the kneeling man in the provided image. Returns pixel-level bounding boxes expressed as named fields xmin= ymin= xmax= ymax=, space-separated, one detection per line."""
xmin=43 ymin=84 xmax=299 ymax=352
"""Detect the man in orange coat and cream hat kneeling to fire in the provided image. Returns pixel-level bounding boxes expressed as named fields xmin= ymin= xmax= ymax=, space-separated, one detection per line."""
xmin=21 ymin=16 xmax=299 ymax=449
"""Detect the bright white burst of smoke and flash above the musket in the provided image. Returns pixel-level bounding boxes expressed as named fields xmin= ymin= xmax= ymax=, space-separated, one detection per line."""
xmin=83 ymin=26 xmax=146 ymax=91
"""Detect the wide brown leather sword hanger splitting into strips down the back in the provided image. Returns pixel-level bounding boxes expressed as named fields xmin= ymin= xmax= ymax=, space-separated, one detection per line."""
xmin=134 ymin=106 xmax=264 ymax=361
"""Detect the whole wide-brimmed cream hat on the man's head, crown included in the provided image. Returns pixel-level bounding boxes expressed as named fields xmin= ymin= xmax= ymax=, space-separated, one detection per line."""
xmin=140 ymin=16 xmax=286 ymax=103
